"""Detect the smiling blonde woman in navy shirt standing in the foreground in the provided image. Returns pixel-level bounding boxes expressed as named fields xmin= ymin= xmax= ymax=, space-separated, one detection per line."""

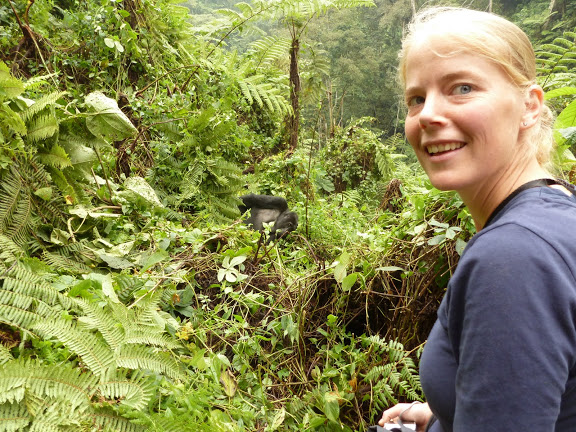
xmin=380 ymin=8 xmax=576 ymax=432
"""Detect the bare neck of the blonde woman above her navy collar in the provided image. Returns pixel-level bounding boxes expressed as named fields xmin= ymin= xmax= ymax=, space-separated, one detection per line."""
xmin=457 ymin=161 xmax=552 ymax=231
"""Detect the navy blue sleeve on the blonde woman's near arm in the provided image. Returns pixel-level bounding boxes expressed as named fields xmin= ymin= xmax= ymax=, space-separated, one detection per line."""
xmin=446 ymin=225 xmax=576 ymax=432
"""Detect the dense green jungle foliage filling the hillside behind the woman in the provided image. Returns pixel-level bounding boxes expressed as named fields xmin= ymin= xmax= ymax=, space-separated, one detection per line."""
xmin=0 ymin=0 xmax=576 ymax=432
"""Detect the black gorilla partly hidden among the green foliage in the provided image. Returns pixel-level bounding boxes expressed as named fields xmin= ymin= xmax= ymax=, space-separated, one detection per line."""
xmin=240 ymin=194 xmax=298 ymax=243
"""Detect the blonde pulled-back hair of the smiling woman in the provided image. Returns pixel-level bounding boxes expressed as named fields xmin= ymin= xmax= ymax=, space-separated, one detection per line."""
xmin=399 ymin=7 xmax=554 ymax=166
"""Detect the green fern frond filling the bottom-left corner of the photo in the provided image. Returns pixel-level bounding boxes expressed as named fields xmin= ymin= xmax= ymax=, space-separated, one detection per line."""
xmin=0 ymin=359 xmax=153 ymax=432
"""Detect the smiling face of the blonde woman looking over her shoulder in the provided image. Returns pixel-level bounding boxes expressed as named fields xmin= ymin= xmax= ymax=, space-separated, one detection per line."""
xmin=405 ymin=41 xmax=525 ymax=195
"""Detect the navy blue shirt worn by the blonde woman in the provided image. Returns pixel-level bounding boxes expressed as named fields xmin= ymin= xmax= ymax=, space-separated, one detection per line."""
xmin=420 ymin=187 xmax=576 ymax=432
